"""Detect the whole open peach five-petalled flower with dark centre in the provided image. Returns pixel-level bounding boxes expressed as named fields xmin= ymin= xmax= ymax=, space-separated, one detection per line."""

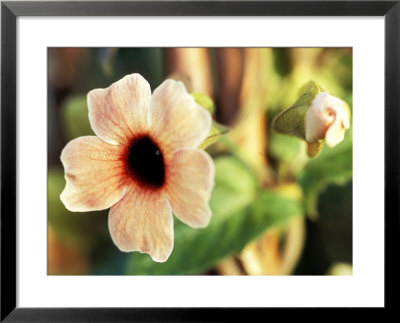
xmin=61 ymin=74 xmax=215 ymax=262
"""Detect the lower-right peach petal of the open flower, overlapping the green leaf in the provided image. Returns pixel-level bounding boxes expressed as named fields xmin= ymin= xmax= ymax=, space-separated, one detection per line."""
xmin=167 ymin=149 xmax=215 ymax=228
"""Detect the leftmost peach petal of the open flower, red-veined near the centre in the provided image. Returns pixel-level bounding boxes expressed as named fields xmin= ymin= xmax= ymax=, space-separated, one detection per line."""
xmin=60 ymin=136 xmax=126 ymax=212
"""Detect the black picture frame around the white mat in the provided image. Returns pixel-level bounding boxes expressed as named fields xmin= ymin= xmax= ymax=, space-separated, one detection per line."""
xmin=1 ymin=0 xmax=400 ymax=322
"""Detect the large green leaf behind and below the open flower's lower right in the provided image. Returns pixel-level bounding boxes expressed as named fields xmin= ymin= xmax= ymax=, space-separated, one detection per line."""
xmin=127 ymin=157 xmax=303 ymax=275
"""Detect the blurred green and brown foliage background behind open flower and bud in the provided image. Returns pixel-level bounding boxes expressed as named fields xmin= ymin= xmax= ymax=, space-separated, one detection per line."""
xmin=48 ymin=48 xmax=352 ymax=275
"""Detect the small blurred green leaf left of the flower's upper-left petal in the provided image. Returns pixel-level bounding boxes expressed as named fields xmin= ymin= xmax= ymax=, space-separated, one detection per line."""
xmin=61 ymin=95 xmax=94 ymax=140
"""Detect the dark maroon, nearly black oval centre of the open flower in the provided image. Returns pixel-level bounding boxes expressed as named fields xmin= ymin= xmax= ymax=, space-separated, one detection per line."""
xmin=127 ymin=136 xmax=165 ymax=187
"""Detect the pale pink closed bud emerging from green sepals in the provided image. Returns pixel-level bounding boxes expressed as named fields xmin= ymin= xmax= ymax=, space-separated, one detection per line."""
xmin=305 ymin=92 xmax=350 ymax=147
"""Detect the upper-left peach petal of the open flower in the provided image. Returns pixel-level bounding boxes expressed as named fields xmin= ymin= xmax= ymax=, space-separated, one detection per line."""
xmin=88 ymin=74 xmax=151 ymax=144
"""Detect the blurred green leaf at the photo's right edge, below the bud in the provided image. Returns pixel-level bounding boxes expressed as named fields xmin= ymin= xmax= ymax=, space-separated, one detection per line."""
xmin=298 ymin=130 xmax=353 ymax=219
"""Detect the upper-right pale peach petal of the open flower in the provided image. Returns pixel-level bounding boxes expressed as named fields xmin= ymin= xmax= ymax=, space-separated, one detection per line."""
xmin=149 ymin=80 xmax=211 ymax=153
